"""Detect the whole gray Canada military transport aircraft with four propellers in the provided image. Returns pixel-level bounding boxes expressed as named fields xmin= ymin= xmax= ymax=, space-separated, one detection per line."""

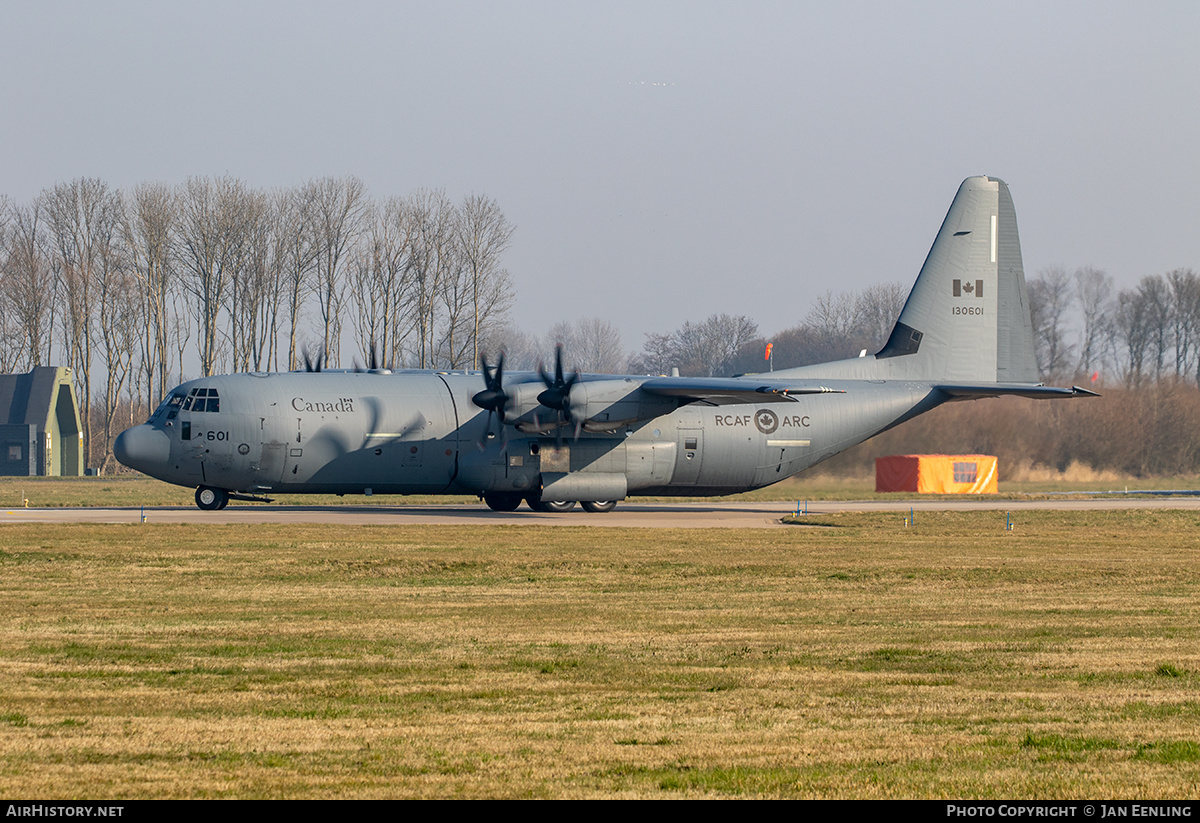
xmin=113 ymin=176 xmax=1094 ymax=511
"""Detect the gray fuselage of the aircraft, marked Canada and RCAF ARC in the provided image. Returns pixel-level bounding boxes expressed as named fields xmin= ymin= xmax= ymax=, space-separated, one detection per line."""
xmin=114 ymin=371 xmax=944 ymax=500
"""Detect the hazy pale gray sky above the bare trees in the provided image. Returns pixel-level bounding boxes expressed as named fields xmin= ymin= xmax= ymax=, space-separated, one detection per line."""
xmin=0 ymin=0 xmax=1200 ymax=349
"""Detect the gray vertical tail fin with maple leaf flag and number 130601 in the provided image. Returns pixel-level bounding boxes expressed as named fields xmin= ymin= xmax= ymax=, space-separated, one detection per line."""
xmin=876 ymin=178 xmax=1038 ymax=383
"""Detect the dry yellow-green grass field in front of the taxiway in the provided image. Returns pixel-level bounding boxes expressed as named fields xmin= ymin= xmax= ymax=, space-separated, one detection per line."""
xmin=0 ymin=511 xmax=1200 ymax=798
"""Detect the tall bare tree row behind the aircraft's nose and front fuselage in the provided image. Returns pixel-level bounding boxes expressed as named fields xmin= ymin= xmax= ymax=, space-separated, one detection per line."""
xmin=0 ymin=176 xmax=514 ymax=467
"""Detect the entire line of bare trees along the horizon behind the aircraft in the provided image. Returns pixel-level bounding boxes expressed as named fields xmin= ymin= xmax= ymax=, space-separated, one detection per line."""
xmin=0 ymin=176 xmax=1200 ymax=473
